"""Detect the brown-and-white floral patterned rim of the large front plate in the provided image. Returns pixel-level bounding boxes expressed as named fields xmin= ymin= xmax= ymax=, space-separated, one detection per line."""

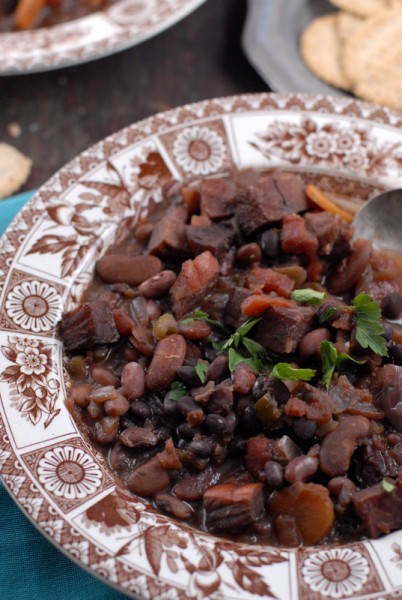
xmin=0 ymin=94 xmax=402 ymax=600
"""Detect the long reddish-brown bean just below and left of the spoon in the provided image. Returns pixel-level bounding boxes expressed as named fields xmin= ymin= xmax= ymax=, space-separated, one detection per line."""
xmin=326 ymin=240 xmax=372 ymax=296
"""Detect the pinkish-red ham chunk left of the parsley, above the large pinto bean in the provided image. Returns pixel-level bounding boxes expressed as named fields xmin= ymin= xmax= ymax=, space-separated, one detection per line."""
xmin=170 ymin=250 xmax=219 ymax=319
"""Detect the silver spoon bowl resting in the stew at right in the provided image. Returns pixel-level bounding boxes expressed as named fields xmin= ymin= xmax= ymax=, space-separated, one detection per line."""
xmin=352 ymin=189 xmax=402 ymax=254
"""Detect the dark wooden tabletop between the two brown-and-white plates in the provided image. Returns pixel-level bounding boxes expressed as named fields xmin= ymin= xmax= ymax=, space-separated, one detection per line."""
xmin=0 ymin=0 xmax=267 ymax=189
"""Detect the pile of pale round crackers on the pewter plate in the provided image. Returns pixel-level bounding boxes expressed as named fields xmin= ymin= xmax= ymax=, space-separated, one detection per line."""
xmin=300 ymin=0 xmax=402 ymax=110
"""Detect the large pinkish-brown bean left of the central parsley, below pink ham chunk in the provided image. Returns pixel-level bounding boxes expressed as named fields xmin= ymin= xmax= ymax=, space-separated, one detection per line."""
xmin=145 ymin=333 xmax=186 ymax=392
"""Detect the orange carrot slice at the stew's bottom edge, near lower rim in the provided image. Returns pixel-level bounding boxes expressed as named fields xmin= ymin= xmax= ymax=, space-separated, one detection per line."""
xmin=270 ymin=481 xmax=334 ymax=544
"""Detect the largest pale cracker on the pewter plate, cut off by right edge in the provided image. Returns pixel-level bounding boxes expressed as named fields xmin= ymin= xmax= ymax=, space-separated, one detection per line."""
xmin=343 ymin=6 xmax=402 ymax=110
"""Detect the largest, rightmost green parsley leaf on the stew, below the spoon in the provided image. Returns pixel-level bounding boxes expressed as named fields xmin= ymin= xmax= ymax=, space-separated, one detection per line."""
xmin=353 ymin=292 xmax=388 ymax=356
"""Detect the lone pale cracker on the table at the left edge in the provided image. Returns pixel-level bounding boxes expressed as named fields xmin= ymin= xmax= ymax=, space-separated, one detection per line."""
xmin=0 ymin=142 xmax=32 ymax=198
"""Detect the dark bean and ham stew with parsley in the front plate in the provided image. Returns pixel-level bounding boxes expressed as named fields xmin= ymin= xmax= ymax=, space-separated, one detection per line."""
xmin=61 ymin=171 xmax=402 ymax=547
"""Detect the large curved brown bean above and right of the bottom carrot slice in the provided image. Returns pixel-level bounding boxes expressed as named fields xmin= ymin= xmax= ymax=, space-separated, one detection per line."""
xmin=320 ymin=415 xmax=370 ymax=477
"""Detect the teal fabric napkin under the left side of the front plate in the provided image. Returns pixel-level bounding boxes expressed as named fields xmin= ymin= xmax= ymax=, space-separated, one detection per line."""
xmin=0 ymin=192 xmax=127 ymax=600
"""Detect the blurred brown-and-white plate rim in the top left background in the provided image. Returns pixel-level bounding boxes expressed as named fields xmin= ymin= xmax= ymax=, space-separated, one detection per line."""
xmin=0 ymin=0 xmax=205 ymax=75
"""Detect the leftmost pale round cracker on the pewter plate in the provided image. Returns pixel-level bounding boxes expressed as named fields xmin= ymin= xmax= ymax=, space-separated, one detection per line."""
xmin=300 ymin=13 xmax=349 ymax=90
